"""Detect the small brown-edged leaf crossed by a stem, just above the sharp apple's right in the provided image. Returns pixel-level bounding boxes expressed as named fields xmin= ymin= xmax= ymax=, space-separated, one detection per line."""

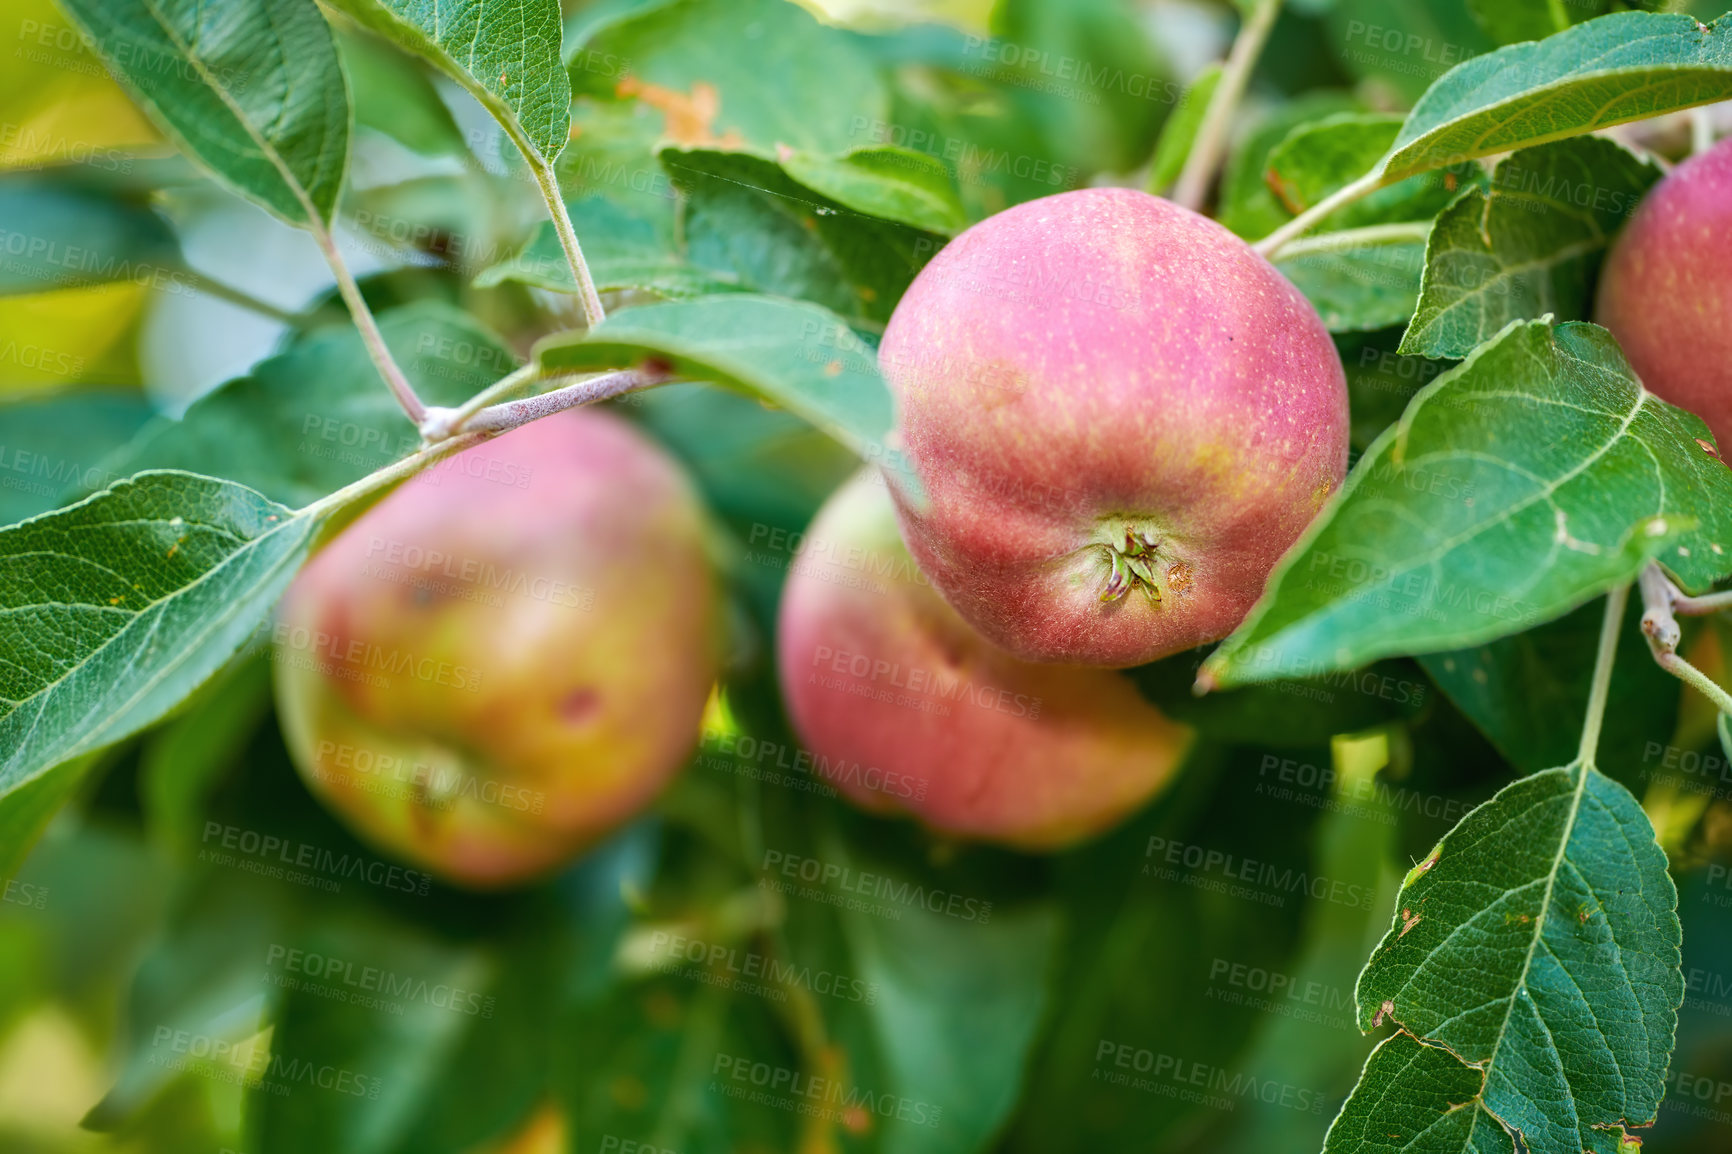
xmin=1266 ymin=113 xmax=1479 ymax=229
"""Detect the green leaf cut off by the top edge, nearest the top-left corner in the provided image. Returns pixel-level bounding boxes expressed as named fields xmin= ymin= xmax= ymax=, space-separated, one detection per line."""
xmin=62 ymin=0 xmax=350 ymax=225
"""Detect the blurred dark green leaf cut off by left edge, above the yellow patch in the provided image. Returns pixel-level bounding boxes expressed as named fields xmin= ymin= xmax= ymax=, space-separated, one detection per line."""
xmin=0 ymin=180 xmax=185 ymax=296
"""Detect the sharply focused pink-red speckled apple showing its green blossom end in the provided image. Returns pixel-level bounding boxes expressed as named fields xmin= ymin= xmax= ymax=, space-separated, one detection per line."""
xmin=880 ymin=189 xmax=1347 ymax=667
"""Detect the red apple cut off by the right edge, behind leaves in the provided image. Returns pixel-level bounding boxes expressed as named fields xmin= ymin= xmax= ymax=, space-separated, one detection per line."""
xmin=1593 ymin=140 xmax=1732 ymax=452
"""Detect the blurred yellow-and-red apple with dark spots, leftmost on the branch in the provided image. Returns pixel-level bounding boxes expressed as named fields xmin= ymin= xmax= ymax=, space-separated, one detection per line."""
xmin=275 ymin=409 xmax=721 ymax=889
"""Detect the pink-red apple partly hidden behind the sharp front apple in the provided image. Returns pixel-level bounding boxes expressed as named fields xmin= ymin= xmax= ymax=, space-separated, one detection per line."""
xmin=778 ymin=473 xmax=1193 ymax=851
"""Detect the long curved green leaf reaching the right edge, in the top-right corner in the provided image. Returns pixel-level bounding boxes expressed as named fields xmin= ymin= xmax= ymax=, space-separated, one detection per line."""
xmin=1382 ymin=12 xmax=1732 ymax=182
